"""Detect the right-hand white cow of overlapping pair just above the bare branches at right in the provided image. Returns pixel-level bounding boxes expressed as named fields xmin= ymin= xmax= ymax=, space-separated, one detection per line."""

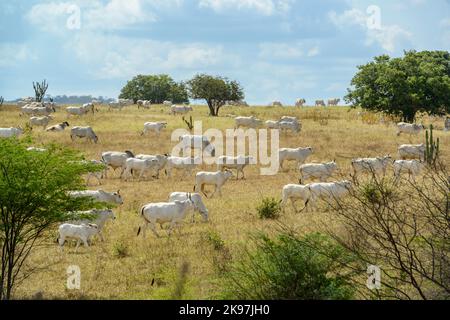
xmin=306 ymin=180 xmax=352 ymax=211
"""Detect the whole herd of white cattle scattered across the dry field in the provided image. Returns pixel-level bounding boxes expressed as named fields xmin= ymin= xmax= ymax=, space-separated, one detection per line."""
xmin=0 ymin=98 xmax=444 ymax=250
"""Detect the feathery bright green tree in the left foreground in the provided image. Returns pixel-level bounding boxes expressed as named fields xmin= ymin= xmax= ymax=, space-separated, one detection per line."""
xmin=0 ymin=139 xmax=103 ymax=300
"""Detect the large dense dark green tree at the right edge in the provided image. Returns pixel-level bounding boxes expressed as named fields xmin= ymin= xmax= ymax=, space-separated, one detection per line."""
xmin=345 ymin=51 xmax=450 ymax=122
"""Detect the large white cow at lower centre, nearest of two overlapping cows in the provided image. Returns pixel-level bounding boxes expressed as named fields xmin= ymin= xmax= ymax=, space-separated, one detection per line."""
xmin=137 ymin=198 xmax=195 ymax=238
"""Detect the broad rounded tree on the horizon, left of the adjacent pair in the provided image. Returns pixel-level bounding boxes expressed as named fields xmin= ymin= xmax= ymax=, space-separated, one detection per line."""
xmin=119 ymin=74 xmax=189 ymax=103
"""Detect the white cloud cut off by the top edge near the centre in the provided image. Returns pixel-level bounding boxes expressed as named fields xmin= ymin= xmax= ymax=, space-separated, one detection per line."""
xmin=199 ymin=0 xmax=293 ymax=16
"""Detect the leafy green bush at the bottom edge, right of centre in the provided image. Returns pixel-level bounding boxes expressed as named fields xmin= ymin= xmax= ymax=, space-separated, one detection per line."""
xmin=224 ymin=233 xmax=354 ymax=300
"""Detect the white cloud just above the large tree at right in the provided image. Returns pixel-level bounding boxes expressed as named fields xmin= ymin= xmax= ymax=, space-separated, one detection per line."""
xmin=329 ymin=8 xmax=412 ymax=52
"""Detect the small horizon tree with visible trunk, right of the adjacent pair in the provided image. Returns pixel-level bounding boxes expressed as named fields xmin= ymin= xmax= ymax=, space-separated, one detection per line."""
xmin=187 ymin=74 xmax=244 ymax=116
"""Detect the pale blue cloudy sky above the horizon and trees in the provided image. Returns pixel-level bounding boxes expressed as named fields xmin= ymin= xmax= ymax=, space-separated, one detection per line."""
xmin=0 ymin=0 xmax=450 ymax=104
